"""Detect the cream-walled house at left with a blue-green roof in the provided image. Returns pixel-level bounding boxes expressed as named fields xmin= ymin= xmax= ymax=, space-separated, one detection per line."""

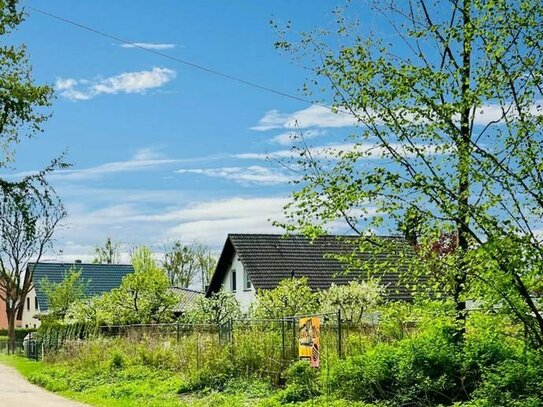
xmin=22 ymin=260 xmax=134 ymax=328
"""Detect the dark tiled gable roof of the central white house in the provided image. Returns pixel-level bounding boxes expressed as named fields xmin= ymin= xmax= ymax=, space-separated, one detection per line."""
xmin=206 ymin=234 xmax=413 ymax=300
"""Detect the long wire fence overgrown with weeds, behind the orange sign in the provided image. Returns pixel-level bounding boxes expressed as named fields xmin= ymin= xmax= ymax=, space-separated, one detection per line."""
xmin=24 ymin=312 xmax=382 ymax=380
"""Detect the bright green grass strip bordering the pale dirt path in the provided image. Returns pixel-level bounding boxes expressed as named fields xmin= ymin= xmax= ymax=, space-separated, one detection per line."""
xmin=0 ymin=355 xmax=278 ymax=407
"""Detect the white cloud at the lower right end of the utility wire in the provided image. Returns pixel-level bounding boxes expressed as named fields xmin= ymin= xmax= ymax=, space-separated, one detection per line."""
xmin=251 ymin=105 xmax=359 ymax=131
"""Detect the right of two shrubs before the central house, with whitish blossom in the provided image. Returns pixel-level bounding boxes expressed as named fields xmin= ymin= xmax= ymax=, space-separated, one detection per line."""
xmin=320 ymin=279 xmax=384 ymax=324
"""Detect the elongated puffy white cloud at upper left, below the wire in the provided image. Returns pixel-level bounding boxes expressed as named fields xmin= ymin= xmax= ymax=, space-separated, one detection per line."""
xmin=55 ymin=67 xmax=176 ymax=100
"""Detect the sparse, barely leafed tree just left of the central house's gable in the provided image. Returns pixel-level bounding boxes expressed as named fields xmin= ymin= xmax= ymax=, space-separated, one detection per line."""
xmin=162 ymin=241 xmax=215 ymax=289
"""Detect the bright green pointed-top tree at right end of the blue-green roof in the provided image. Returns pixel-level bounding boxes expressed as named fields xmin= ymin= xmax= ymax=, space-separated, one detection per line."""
xmin=100 ymin=247 xmax=177 ymax=324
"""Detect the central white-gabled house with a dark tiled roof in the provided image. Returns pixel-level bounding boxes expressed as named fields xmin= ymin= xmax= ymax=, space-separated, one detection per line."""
xmin=206 ymin=234 xmax=411 ymax=311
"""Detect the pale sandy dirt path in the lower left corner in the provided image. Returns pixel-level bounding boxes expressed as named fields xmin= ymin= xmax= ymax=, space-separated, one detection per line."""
xmin=0 ymin=364 xmax=89 ymax=407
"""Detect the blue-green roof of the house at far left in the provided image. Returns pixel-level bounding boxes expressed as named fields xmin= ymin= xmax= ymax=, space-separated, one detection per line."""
xmin=29 ymin=263 xmax=134 ymax=312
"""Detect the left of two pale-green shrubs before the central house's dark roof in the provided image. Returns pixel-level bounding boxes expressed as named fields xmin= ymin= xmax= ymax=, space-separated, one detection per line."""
xmin=251 ymin=277 xmax=319 ymax=319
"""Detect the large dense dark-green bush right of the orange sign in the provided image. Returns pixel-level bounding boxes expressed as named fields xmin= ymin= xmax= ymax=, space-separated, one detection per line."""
xmin=328 ymin=330 xmax=466 ymax=406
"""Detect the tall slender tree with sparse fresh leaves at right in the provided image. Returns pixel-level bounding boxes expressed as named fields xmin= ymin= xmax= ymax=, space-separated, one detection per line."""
xmin=277 ymin=0 xmax=543 ymax=346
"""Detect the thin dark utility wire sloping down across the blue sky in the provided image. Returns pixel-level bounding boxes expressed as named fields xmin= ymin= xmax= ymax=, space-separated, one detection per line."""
xmin=25 ymin=6 xmax=344 ymax=114
